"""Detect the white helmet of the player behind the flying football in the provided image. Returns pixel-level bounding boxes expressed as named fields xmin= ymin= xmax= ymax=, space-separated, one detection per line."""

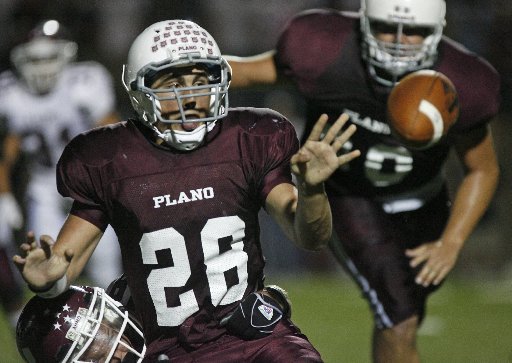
xmin=361 ymin=0 xmax=446 ymax=86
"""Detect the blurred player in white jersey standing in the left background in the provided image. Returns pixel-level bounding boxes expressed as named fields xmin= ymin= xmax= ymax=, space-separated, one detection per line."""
xmin=0 ymin=20 xmax=121 ymax=287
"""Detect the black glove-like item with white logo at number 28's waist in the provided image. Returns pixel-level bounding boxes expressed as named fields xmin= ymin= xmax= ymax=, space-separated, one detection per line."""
xmin=220 ymin=285 xmax=291 ymax=340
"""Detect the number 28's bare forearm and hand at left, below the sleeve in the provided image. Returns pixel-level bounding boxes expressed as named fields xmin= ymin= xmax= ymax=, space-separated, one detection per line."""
xmin=13 ymin=214 xmax=103 ymax=297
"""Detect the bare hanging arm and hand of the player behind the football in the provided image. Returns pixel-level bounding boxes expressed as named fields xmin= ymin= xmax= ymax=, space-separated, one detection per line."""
xmin=407 ymin=126 xmax=499 ymax=286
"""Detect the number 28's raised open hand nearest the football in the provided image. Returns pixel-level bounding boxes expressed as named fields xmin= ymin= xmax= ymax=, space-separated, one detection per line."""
xmin=291 ymin=114 xmax=361 ymax=186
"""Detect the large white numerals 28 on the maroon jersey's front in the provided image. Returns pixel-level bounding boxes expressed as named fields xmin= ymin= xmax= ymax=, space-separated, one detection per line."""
xmin=139 ymin=216 xmax=248 ymax=326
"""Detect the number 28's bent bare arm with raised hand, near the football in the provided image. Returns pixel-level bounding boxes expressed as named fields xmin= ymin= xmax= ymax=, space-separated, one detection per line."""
xmin=266 ymin=115 xmax=360 ymax=250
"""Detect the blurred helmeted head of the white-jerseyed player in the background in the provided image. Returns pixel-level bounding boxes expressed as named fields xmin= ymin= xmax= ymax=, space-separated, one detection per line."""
xmin=11 ymin=20 xmax=78 ymax=94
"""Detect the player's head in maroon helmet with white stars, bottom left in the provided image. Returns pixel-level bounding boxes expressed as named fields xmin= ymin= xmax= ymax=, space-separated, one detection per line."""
xmin=16 ymin=286 xmax=146 ymax=363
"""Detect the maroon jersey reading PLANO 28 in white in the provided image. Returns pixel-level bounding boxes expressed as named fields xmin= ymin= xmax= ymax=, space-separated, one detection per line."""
xmin=57 ymin=108 xmax=298 ymax=354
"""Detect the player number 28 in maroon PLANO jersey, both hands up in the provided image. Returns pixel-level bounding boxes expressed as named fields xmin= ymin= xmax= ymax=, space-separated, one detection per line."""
xmin=14 ymin=20 xmax=359 ymax=363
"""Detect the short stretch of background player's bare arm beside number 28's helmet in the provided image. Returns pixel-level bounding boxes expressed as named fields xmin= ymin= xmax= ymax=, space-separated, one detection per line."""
xmin=224 ymin=50 xmax=277 ymax=87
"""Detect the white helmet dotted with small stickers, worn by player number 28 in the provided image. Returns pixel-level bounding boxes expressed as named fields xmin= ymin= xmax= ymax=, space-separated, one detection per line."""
xmin=123 ymin=20 xmax=231 ymax=151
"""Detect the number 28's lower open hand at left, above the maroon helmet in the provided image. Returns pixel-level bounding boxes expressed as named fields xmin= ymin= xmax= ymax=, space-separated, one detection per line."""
xmin=13 ymin=232 xmax=73 ymax=290
